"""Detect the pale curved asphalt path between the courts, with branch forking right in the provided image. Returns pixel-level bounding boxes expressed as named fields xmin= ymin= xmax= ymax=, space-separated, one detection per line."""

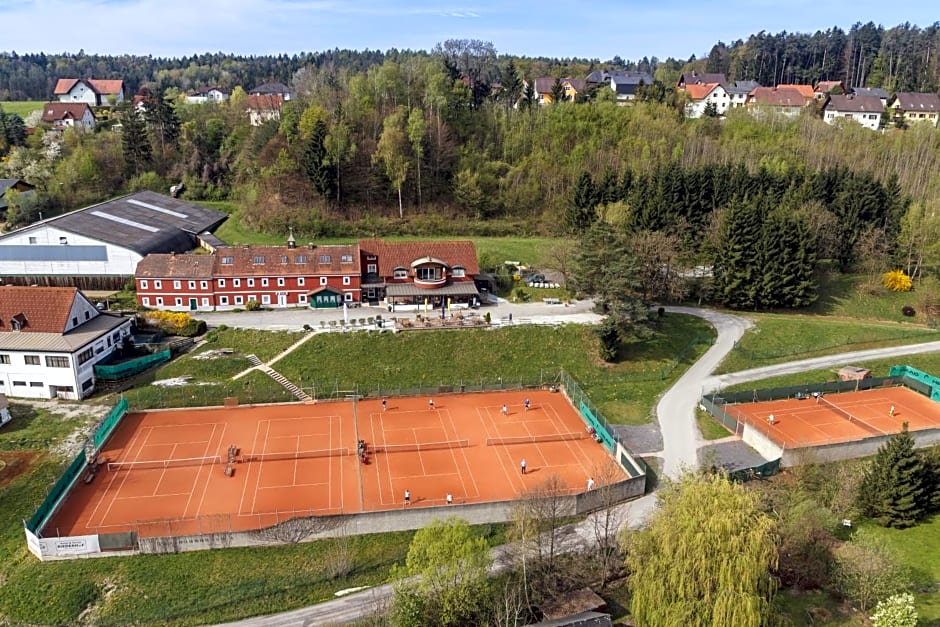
xmin=222 ymin=307 xmax=940 ymax=627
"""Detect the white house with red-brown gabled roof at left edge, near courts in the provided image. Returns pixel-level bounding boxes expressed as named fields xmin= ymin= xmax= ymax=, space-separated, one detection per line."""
xmin=0 ymin=285 xmax=131 ymax=400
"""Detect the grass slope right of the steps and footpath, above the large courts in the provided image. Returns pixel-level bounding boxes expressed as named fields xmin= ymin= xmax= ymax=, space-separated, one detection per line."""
xmin=276 ymin=315 xmax=714 ymax=424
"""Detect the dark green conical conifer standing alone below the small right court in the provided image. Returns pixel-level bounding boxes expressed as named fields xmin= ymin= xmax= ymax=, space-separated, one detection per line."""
xmin=858 ymin=422 xmax=931 ymax=528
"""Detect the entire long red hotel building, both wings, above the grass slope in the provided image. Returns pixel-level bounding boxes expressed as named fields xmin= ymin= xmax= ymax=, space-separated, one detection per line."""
xmin=136 ymin=240 xmax=480 ymax=311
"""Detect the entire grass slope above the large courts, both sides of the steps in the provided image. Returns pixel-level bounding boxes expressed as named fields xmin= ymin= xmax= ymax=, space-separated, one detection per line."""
xmin=138 ymin=315 xmax=714 ymax=424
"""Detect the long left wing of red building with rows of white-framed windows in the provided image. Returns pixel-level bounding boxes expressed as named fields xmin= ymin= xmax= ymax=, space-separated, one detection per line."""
xmin=135 ymin=239 xmax=362 ymax=311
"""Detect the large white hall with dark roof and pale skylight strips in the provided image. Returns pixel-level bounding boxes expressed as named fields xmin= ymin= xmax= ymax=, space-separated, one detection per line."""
xmin=0 ymin=191 xmax=227 ymax=289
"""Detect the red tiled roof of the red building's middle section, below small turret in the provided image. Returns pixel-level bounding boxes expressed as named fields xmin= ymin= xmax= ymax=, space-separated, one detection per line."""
xmin=212 ymin=244 xmax=360 ymax=277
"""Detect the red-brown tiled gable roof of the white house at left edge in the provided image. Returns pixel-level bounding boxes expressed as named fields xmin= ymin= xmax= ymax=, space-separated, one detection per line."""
xmin=0 ymin=285 xmax=78 ymax=333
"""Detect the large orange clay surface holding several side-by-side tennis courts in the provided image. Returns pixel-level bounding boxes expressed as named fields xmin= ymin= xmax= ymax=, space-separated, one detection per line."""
xmin=43 ymin=391 xmax=613 ymax=537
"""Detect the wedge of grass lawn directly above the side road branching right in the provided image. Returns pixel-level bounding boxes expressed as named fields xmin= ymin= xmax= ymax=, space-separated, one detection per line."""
xmin=718 ymin=314 xmax=940 ymax=373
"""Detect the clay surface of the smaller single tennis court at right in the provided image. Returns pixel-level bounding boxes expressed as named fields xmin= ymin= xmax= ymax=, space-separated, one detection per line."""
xmin=726 ymin=387 xmax=940 ymax=448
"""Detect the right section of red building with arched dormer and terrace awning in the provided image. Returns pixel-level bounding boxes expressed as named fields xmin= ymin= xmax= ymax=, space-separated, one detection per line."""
xmin=359 ymin=240 xmax=481 ymax=310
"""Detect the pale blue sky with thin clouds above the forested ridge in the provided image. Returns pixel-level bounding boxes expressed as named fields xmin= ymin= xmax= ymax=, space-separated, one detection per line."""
xmin=0 ymin=0 xmax=940 ymax=61
